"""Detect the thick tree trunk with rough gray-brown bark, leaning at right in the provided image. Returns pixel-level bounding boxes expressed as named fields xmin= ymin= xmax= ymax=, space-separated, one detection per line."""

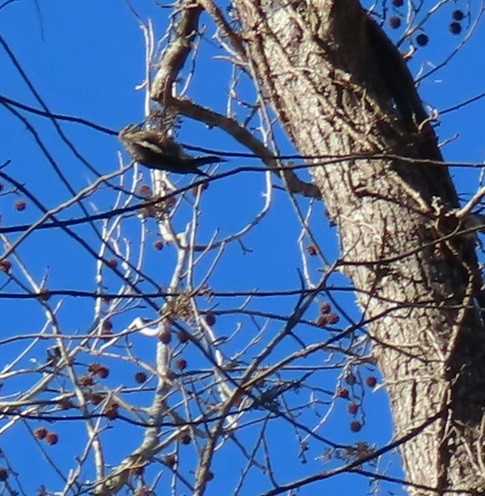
xmin=234 ymin=0 xmax=485 ymax=495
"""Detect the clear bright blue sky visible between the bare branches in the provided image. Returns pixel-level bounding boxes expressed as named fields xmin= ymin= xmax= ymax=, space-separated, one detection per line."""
xmin=0 ymin=0 xmax=485 ymax=496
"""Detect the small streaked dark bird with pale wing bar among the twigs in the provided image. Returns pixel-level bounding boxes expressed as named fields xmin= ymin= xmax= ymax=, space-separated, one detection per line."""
xmin=118 ymin=124 xmax=225 ymax=177
